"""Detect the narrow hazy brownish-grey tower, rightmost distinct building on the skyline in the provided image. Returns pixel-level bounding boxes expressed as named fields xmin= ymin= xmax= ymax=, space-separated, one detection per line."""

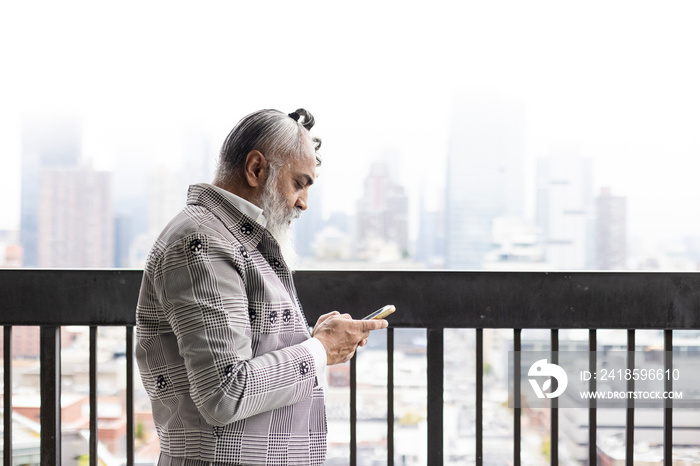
xmin=596 ymin=188 xmax=627 ymax=270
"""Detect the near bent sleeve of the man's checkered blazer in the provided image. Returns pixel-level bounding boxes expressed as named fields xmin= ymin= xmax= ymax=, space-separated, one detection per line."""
xmin=154 ymin=233 xmax=316 ymax=426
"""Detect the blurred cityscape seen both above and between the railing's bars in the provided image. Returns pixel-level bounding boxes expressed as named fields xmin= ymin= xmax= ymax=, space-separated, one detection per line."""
xmin=0 ymin=104 xmax=700 ymax=466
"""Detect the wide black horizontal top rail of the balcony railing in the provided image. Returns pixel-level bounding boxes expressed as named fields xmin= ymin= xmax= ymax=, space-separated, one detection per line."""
xmin=0 ymin=269 xmax=700 ymax=329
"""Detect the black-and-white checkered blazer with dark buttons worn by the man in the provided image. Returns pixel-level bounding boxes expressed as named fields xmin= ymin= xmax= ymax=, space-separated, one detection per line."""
xmin=136 ymin=185 xmax=326 ymax=466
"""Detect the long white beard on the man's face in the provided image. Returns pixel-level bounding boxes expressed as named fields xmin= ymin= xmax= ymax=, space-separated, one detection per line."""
xmin=260 ymin=171 xmax=301 ymax=270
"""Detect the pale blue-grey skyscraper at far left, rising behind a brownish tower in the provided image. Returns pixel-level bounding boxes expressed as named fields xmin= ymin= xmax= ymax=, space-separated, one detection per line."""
xmin=20 ymin=114 xmax=82 ymax=267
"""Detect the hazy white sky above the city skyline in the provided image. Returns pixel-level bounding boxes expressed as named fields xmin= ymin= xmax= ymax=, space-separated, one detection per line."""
xmin=0 ymin=0 xmax=700 ymax=244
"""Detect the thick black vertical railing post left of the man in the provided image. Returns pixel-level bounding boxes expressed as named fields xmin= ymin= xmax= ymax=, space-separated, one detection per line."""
xmin=40 ymin=325 xmax=61 ymax=466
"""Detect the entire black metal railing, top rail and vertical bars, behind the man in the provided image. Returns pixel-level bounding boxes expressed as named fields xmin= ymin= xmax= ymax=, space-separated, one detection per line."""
xmin=0 ymin=269 xmax=700 ymax=466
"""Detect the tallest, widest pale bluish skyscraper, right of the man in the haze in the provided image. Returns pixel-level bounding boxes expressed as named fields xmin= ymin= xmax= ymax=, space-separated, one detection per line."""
xmin=445 ymin=100 xmax=525 ymax=270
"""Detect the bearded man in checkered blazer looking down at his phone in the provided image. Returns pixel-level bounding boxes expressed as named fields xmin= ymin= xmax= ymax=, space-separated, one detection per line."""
xmin=136 ymin=109 xmax=387 ymax=466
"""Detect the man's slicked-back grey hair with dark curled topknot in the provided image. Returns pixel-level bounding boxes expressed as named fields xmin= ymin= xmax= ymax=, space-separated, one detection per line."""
xmin=216 ymin=108 xmax=321 ymax=180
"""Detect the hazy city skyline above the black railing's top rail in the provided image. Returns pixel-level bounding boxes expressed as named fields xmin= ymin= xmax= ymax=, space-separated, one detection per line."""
xmin=8 ymin=104 xmax=700 ymax=271
